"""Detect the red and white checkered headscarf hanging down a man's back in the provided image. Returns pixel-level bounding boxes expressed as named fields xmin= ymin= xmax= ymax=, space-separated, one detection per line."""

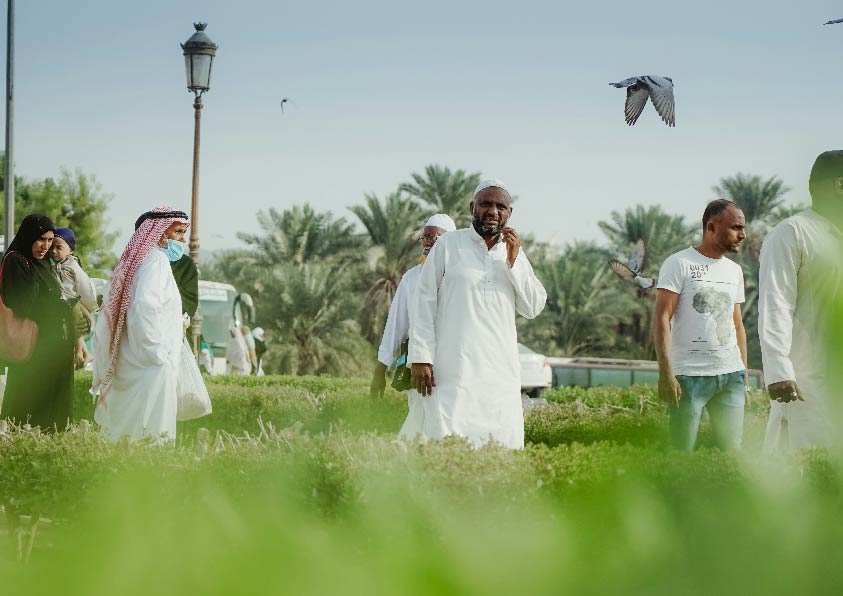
xmin=93 ymin=207 xmax=189 ymax=403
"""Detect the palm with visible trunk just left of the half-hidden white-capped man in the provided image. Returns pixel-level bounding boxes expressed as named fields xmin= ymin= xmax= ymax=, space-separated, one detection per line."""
xmin=349 ymin=191 xmax=423 ymax=344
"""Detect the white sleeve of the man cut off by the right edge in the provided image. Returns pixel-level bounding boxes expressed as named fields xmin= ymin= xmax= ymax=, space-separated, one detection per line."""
xmin=758 ymin=225 xmax=802 ymax=385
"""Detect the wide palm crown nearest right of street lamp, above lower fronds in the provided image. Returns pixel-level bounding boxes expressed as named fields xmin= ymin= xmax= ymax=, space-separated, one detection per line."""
xmin=237 ymin=204 xmax=365 ymax=266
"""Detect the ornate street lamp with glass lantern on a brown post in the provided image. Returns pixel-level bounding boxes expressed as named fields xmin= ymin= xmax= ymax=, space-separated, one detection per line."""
xmin=181 ymin=23 xmax=217 ymax=356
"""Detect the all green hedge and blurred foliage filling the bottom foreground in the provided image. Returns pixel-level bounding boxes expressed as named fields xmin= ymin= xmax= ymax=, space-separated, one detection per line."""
xmin=0 ymin=375 xmax=843 ymax=596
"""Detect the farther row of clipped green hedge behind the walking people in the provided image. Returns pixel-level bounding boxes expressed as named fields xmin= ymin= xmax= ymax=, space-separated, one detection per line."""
xmin=74 ymin=373 xmax=780 ymax=448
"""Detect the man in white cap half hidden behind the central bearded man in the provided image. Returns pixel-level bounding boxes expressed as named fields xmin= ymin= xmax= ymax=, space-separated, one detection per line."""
xmin=369 ymin=213 xmax=457 ymax=398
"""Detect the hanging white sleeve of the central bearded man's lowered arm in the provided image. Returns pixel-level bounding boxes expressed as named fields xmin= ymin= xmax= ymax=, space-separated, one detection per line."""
xmin=407 ymin=241 xmax=446 ymax=364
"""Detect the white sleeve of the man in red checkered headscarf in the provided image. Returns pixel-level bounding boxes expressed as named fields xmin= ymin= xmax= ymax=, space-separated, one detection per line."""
xmin=124 ymin=262 xmax=178 ymax=367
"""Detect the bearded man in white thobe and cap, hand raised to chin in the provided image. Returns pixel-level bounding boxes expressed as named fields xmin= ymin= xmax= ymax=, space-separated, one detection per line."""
xmin=407 ymin=180 xmax=547 ymax=449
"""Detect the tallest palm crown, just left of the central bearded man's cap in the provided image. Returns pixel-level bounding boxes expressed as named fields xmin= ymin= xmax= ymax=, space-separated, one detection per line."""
xmin=399 ymin=164 xmax=481 ymax=227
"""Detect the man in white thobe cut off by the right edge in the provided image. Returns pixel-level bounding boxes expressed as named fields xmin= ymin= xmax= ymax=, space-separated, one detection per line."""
xmin=758 ymin=151 xmax=843 ymax=451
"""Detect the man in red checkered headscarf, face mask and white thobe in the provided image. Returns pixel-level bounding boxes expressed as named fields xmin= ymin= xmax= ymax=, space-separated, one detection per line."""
xmin=93 ymin=207 xmax=188 ymax=441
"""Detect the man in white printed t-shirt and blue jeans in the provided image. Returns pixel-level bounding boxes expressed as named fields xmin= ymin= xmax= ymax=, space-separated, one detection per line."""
xmin=653 ymin=199 xmax=747 ymax=451
